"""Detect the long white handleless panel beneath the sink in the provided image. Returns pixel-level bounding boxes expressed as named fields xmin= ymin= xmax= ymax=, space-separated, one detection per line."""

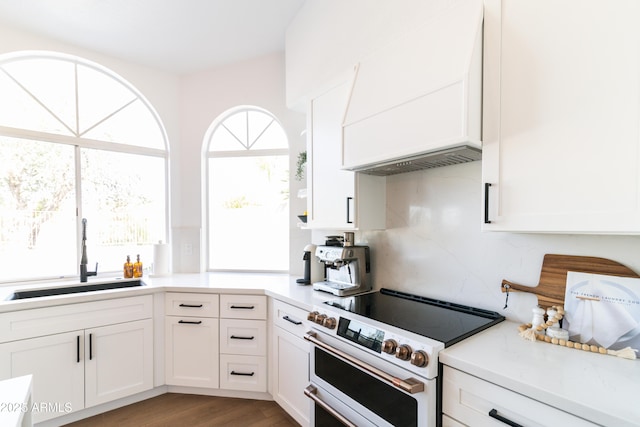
xmin=0 ymin=295 xmax=153 ymax=342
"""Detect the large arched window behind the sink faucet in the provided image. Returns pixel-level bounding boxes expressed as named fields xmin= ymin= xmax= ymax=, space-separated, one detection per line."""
xmin=0 ymin=52 xmax=168 ymax=282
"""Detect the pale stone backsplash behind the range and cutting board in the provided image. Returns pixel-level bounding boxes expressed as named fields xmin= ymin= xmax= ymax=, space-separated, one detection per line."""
xmin=352 ymin=162 xmax=640 ymax=322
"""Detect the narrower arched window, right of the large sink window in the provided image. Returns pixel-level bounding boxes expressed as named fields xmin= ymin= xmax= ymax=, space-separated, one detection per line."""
xmin=204 ymin=106 xmax=289 ymax=271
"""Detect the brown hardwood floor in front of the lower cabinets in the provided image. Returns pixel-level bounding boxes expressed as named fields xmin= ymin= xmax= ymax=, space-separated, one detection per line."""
xmin=67 ymin=393 xmax=298 ymax=427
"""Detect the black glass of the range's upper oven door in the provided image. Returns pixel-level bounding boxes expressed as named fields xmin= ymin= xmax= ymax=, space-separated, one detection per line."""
xmin=314 ymin=347 xmax=419 ymax=427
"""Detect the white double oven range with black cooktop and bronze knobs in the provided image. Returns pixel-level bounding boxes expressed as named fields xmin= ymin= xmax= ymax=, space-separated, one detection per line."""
xmin=304 ymin=289 xmax=504 ymax=427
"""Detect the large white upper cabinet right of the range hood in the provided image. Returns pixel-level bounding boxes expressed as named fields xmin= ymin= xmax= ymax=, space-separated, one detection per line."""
xmin=482 ymin=0 xmax=640 ymax=234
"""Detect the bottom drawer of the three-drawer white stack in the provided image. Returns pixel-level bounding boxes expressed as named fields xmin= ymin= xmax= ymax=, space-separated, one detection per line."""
xmin=220 ymin=354 xmax=267 ymax=392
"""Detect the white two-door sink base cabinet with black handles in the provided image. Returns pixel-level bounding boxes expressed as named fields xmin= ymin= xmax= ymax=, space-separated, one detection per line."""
xmin=0 ymin=296 xmax=154 ymax=423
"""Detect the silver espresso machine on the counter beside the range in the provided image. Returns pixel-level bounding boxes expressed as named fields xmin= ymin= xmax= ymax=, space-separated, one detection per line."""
xmin=313 ymin=246 xmax=371 ymax=296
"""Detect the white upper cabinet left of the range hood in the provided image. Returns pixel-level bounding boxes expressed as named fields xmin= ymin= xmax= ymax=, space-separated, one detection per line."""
xmin=307 ymin=83 xmax=386 ymax=230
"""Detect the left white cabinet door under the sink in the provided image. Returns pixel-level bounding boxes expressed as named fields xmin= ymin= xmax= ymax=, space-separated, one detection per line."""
xmin=0 ymin=331 xmax=84 ymax=423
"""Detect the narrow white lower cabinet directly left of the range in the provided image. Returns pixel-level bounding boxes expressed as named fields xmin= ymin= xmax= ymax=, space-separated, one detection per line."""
xmin=271 ymin=300 xmax=311 ymax=426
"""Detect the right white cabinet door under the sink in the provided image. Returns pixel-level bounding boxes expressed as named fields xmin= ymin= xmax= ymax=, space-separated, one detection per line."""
xmin=85 ymin=319 xmax=153 ymax=407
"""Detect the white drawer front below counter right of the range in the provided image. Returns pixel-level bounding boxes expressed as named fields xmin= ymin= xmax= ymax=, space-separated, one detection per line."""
xmin=442 ymin=366 xmax=596 ymax=427
